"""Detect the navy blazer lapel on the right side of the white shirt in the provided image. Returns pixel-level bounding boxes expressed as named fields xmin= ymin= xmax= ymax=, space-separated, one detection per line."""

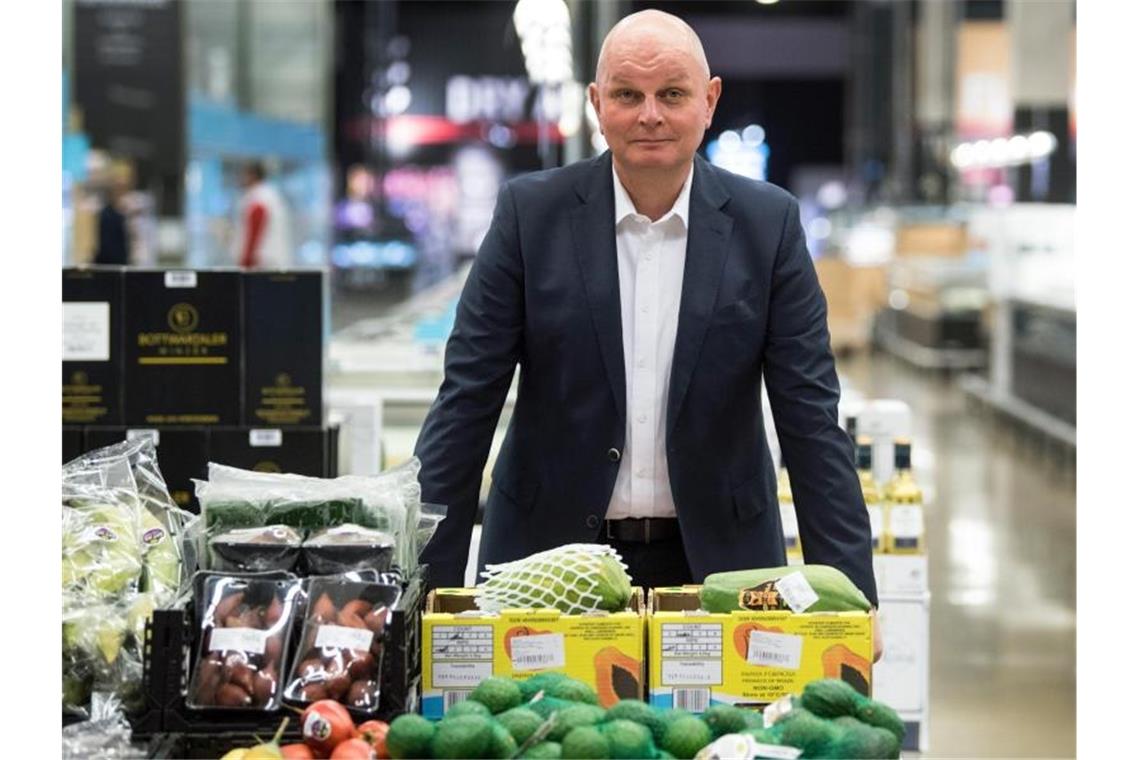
xmin=666 ymin=156 xmax=732 ymax=435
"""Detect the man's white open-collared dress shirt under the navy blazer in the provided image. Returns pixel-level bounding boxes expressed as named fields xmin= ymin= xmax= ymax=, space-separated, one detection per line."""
xmin=605 ymin=167 xmax=693 ymax=520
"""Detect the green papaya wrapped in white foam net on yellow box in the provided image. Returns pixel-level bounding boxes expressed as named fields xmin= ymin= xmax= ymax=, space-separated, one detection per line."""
xmin=475 ymin=544 xmax=630 ymax=614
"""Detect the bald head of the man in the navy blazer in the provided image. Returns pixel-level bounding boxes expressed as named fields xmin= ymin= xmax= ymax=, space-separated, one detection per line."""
xmin=589 ymin=10 xmax=720 ymax=174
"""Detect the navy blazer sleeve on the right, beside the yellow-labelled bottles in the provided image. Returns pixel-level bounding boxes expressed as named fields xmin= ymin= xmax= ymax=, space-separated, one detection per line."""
xmin=763 ymin=198 xmax=879 ymax=606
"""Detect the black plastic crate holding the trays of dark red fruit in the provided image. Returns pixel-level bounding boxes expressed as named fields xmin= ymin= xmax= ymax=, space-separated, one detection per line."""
xmin=131 ymin=567 xmax=426 ymax=757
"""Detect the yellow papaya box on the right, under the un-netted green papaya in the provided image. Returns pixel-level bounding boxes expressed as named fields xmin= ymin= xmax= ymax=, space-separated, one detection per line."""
xmin=649 ymin=586 xmax=872 ymax=712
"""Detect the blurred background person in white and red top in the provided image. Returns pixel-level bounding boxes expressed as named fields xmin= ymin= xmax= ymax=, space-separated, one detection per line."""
xmin=235 ymin=161 xmax=293 ymax=269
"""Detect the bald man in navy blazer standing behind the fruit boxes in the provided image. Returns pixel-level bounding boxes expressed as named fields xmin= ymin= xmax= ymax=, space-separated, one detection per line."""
xmin=416 ymin=10 xmax=877 ymax=647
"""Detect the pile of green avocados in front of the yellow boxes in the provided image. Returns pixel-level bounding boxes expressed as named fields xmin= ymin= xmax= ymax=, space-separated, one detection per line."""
xmin=388 ymin=672 xmax=905 ymax=760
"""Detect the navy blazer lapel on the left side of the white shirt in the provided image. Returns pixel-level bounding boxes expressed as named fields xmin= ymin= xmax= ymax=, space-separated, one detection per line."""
xmin=570 ymin=152 xmax=626 ymax=426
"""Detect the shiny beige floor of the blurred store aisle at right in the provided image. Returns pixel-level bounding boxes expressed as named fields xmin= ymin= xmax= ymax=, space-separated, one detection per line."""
xmin=839 ymin=354 xmax=1076 ymax=758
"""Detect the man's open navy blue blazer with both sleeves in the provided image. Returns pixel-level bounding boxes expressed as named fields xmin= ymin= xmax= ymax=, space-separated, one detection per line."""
xmin=415 ymin=152 xmax=877 ymax=603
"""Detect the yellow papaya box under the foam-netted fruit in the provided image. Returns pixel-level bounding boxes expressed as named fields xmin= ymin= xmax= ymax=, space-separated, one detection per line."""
xmin=421 ymin=588 xmax=645 ymax=718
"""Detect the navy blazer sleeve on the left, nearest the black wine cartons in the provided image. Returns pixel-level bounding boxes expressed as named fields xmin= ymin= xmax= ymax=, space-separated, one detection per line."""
xmin=415 ymin=183 xmax=524 ymax=588
